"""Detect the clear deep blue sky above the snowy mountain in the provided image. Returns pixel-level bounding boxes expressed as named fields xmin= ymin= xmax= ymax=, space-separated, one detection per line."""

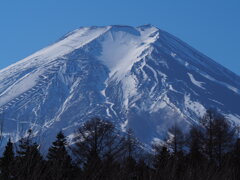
xmin=0 ymin=0 xmax=240 ymax=75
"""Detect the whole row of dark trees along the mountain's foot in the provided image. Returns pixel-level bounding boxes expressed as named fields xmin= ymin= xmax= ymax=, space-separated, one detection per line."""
xmin=0 ymin=110 xmax=240 ymax=180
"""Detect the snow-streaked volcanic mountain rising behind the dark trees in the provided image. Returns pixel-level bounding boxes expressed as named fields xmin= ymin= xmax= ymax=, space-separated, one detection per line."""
xmin=0 ymin=25 xmax=240 ymax=148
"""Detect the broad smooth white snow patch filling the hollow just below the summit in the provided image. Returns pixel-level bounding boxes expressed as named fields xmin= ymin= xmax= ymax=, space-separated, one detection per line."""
xmin=99 ymin=25 xmax=159 ymax=79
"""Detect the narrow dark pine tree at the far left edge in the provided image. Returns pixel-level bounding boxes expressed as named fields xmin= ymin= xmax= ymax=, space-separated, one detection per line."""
xmin=0 ymin=138 xmax=14 ymax=180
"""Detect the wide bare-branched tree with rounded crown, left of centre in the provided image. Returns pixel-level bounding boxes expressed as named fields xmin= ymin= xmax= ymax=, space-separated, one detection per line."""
xmin=72 ymin=118 xmax=124 ymax=179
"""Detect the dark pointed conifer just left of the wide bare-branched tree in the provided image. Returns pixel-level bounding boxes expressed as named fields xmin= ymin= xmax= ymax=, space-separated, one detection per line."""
xmin=47 ymin=131 xmax=73 ymax=180
